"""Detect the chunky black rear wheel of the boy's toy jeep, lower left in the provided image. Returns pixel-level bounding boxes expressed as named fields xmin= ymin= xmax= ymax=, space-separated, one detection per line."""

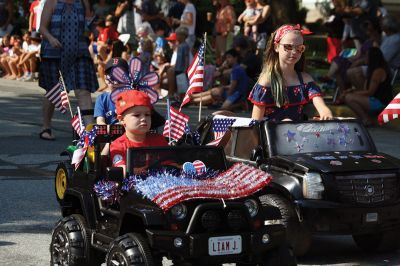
xmin=50 ymin=214 xmax=104 ymax=266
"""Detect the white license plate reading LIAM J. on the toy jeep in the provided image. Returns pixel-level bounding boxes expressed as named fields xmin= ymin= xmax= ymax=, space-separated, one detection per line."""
xmin=208 ymin=236 xmax=242 ymax=256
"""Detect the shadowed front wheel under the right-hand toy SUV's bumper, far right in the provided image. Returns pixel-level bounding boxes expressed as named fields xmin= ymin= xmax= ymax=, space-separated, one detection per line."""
xmin=353 ymin=230 xmax=400 ymax=252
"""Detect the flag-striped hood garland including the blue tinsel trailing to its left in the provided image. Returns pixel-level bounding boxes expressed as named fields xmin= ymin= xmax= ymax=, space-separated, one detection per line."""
xmin=95 ymin=163 xmax=272 ymax=211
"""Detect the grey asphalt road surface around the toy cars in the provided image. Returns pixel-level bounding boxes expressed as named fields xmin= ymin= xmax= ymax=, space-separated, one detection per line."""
xmin=0 ymin=79 xmax=400 ymax=266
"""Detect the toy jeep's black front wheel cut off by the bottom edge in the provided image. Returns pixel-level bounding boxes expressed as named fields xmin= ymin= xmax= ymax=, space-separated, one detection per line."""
xmin=106 ymin=233 xmax=154 ymax=266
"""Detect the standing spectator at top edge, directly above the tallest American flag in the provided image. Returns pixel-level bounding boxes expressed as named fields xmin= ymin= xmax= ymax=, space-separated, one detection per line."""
xmin=172 ymin=0 xmax=196 ymax=48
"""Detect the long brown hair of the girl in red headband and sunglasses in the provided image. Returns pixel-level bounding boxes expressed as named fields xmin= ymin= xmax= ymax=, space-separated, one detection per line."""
xmin=259 ymin=25 xmax=304 ymax=107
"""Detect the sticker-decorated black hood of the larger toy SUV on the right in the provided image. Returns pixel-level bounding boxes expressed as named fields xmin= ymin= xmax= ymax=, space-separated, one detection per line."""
xmin=276 ymin=152 xmax=400 ymax=173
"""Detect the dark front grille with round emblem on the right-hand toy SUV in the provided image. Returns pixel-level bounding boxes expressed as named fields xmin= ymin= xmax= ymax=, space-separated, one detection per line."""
xmin=336 ymin=173 xmax=400 ymax=204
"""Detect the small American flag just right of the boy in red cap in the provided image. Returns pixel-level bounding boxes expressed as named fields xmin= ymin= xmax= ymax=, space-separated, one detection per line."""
xmin=163 ymin=106 xmax=189 ymax=140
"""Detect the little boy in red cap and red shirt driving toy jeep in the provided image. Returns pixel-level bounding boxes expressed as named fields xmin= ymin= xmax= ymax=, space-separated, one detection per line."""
xmin=110 ymin=90 xmax=168 ymax=175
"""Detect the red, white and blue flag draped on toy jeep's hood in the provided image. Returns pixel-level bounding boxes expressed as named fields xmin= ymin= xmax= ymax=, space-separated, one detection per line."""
xmin=141 ymin=163 xmax=272 ymax=211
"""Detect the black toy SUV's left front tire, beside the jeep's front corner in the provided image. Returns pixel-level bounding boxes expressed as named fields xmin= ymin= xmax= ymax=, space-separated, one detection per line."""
xmin=260 ymin=194 xmax=311 ymax=256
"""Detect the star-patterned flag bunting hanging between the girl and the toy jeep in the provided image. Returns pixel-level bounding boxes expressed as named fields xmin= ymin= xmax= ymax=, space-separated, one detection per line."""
xmin=207 ymin=115 xmax=256 ymax=146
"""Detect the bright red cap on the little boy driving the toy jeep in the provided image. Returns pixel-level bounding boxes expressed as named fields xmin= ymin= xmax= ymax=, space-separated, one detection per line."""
xmin=115 ymin=90 xmax=153 ymax=115
